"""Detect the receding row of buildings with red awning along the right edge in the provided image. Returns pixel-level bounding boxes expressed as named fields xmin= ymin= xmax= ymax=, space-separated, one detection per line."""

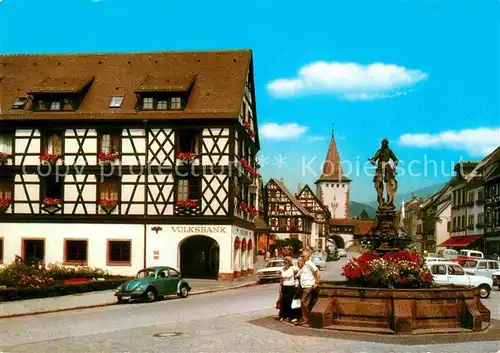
xmin=399 ymin=147 xmax=500 ymax=255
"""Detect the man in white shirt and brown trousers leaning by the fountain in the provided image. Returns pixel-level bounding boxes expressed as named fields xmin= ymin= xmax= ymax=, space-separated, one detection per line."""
xmin=299 ymin=251 xmax=319 ymax=327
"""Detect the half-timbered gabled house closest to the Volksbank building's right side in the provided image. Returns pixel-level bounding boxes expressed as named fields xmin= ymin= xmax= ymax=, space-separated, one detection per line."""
xmin=265 ymin=178 xmax=314 ymax=248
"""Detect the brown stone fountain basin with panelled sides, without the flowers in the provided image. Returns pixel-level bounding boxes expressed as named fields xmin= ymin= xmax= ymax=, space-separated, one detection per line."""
xmin=311 ymin=281 xmax=491 ymax=335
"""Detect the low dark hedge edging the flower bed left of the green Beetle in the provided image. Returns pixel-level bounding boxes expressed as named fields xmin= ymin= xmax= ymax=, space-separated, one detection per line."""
xmin=0 ymin=277 xmax=130 ymax=302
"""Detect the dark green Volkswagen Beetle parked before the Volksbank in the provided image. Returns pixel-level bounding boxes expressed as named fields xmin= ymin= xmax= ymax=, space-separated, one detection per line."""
xmin=115 ymin=266 xmax=191 ymax=303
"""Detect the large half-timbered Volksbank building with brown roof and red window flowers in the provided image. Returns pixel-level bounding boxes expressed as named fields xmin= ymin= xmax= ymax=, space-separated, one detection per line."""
xmin=0 ymin=50 xmax=260 ymax=280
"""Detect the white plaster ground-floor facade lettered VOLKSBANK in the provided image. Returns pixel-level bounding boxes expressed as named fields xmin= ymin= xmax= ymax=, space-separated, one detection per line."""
xmin=0 ymin=223 xmax=255 ymax=275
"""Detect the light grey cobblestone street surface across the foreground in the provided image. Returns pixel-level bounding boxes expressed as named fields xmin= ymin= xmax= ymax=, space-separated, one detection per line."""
xmin=0 ymin=254 xmax=500 ymax=353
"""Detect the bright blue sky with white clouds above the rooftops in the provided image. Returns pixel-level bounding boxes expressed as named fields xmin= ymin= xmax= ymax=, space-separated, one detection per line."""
xmin=0 ymin=0 xmax=500 ymax=201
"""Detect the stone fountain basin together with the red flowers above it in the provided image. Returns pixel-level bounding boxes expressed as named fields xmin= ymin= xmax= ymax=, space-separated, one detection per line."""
xmin=311 ymin=250 xmax=490 ymax=334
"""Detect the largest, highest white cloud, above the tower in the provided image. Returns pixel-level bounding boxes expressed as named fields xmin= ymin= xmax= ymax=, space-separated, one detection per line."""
xmin=267 ymin=61 xmax=428 ymax=100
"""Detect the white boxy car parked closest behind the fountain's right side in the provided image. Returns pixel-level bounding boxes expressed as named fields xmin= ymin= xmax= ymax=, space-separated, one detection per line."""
xmin=427 ymin=261 xmax=493 ymax=299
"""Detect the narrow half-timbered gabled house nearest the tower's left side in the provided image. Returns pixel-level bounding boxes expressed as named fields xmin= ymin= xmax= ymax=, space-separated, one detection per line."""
xmin=297 ymin=184 xmax=331 ymax=251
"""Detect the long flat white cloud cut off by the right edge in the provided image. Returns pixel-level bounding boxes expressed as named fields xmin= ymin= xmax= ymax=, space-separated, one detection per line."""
xmin=399 ymin=128 xmax=500 ymax=157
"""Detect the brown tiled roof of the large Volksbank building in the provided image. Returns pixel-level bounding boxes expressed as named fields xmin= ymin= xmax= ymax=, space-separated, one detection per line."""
xmin=0 ymin=50 xmax=252 ymax=120
